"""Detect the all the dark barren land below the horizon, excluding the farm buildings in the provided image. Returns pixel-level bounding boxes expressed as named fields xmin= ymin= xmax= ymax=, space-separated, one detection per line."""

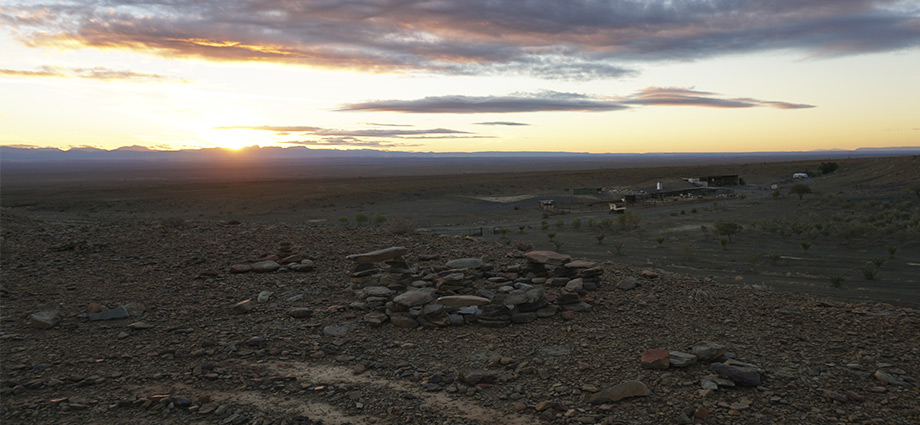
xmin=0 ymin=156 xmax=920 ymax=425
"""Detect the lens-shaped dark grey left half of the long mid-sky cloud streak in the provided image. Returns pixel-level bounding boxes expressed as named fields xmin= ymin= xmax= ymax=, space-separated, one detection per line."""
xmin=339 ymin=91 xmax=626 ymax=114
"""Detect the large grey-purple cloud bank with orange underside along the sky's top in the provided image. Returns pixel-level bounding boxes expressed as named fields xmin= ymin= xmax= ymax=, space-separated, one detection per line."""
xmin=0 ymin=0 xmax=920 ymax=79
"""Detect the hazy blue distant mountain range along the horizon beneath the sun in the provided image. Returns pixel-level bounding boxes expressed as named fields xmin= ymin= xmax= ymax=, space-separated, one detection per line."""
xmin=0 ymin=146 xmax=920 ymax=163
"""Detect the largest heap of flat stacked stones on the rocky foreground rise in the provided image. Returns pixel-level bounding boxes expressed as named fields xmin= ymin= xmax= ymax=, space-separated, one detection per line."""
xmin=346 ymin=247 xmax=603 ymax=328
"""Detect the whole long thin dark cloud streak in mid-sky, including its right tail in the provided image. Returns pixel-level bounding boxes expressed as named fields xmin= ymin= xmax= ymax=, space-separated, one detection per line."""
xmin=339 ymin=87 xmax=814 ymax=112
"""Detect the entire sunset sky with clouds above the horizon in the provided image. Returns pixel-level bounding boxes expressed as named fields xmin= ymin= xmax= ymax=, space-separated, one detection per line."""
xmin=0 ymin=0 xmax=920 ymax=153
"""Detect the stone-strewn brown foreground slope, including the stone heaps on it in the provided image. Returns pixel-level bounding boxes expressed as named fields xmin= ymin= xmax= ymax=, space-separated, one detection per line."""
xmin=0 ymin=211 xmax=920 ymax=425
